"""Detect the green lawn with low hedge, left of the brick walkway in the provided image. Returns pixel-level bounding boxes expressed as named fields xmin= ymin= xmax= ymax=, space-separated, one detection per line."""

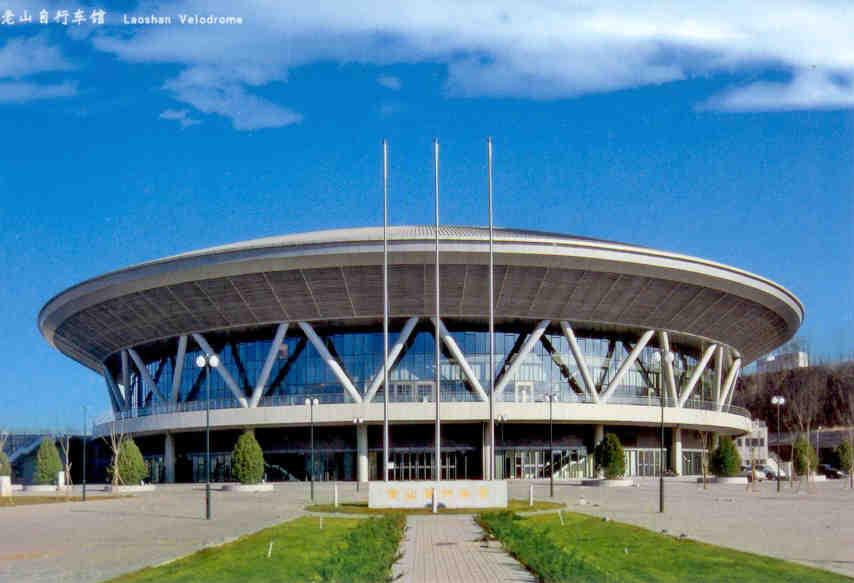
xmin=113 ymin=516 xmax=404 ymax=583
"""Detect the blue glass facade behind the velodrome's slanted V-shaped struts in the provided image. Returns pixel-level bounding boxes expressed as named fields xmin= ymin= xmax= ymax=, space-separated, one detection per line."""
xmin=106 ymin=321 xmax=715 ymax=410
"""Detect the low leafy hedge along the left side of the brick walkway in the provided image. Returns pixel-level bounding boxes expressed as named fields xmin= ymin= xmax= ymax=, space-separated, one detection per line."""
xmin=320 ymin=513 xmax=406 ymax=583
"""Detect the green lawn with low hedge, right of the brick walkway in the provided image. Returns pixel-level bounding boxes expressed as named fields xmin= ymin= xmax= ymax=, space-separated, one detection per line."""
xmin=478 ymin=512 xmax=852 ymax=583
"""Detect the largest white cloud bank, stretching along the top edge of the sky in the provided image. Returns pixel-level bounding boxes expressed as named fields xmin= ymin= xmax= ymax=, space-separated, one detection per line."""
xmin=87 ymin=0 xmax=854 ymax=120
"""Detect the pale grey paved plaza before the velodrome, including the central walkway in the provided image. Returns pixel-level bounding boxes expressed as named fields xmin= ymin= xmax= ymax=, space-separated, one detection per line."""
xmin=0 ymin=480 xmax=854 ymax=582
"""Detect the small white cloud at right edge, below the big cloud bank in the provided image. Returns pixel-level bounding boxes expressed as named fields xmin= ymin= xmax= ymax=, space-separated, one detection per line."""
xmin=706 ymin=70 xmax=854 ymax=112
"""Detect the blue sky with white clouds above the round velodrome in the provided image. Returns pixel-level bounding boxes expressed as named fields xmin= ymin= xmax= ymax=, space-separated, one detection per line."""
xmin=0 ymin=0 xmax=854 ymax=427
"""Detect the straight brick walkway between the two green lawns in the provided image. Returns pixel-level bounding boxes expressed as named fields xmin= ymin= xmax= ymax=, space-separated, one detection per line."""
xmin=394 ymin=515 xmax=536 ymax=583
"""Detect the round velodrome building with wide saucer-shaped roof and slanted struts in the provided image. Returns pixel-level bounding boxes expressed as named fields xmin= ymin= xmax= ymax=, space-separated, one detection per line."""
xmin=39 ymin=226 xmax=804 ymax=481
